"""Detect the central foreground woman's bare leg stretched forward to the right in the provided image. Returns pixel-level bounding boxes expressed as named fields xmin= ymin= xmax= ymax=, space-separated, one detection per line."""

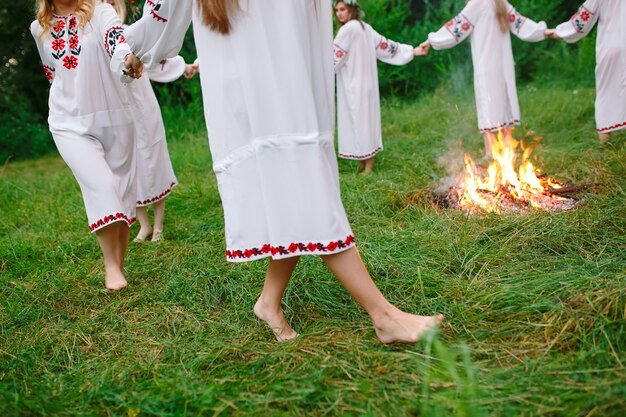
xmin=322 ymin=247 xmax=443 ymax=343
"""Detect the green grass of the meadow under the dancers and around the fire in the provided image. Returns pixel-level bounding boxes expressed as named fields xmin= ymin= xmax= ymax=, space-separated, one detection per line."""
xmin=0 ymin=85 xmax=626 ymax=416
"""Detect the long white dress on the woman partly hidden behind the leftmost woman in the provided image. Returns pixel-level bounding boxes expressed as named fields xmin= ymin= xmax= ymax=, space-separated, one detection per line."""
xmin=130 ymin=56 xmax=185 ymax=207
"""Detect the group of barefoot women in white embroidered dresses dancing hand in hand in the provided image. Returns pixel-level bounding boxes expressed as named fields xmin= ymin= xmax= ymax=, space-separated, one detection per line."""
xmin=31 ymin=0 xmax=626 ymax=343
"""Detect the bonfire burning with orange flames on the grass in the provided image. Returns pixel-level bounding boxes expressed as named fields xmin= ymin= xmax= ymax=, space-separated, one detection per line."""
xmin=438 ymin=130 xmax=578 ymax=212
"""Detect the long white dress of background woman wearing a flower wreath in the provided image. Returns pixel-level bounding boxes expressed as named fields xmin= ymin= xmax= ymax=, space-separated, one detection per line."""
xmin=334 ymin=20 xmax=413 ymax=159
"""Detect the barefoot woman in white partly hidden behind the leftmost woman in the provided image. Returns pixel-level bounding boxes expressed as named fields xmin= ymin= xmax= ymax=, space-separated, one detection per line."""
xmin=101 ymin=0 xmax=197 ymax=242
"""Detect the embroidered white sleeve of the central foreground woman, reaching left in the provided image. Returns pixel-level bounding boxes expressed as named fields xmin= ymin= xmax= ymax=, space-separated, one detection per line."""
xmin=124 ymin=0 xmax=193 ymax=68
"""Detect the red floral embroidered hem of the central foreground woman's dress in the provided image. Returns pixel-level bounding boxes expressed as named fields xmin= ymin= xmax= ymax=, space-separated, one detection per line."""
xmin=226 ymin=235 xmax=355 ymax=262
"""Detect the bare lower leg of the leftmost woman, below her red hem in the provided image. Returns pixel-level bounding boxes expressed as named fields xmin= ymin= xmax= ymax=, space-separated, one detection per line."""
xmin=96 ymin=222 xmax=128 ymax=291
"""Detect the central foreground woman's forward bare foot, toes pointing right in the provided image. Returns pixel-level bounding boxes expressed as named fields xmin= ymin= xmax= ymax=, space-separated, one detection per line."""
xmin=374 ymin=309 xmax=443 ymax=343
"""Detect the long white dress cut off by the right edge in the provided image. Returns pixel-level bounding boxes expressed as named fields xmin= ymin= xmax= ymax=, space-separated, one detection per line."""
xmin=556 ymin=0 xmax=626 ymax=133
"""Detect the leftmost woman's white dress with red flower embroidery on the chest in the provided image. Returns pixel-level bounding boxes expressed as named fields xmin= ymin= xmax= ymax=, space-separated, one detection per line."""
xmin=30 ymin=4 xmax=136 ymax=232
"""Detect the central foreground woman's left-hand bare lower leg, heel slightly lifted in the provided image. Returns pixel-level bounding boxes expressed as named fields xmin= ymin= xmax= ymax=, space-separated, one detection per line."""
xmin=254 ymin=256 xmax=300 ymax=342
